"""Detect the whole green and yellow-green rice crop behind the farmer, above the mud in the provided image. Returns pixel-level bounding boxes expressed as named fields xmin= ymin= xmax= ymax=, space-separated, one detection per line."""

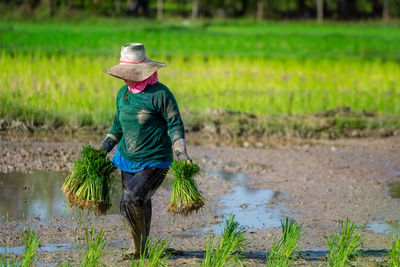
xmin=0 ymin=19 xmax=400 ymax=137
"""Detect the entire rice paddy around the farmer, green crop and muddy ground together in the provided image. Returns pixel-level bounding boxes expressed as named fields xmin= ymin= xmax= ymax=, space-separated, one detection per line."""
xmin=0 ymin=18 xmax=400 ymax=267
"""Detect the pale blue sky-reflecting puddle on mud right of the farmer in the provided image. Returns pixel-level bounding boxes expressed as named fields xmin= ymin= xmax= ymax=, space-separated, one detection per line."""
xmin=207 ymin=170 xmax=282 ymax=233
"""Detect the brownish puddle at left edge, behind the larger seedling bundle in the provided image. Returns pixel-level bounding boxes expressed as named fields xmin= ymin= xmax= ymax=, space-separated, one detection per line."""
xmin=0 ymin=171 xmax=121 ymax=221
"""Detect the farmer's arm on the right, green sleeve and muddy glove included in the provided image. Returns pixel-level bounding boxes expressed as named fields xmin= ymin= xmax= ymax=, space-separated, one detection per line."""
xmin=161 ymin=91 xmax=191 ymax=162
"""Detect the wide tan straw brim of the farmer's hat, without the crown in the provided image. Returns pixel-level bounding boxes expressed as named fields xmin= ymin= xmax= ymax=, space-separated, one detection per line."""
xmin=103 ymin=59 xmax=166 ymax=81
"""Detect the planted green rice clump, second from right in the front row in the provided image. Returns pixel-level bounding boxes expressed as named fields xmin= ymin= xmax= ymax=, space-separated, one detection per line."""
xmin=326 ymin=219 xmax=364 ymax=267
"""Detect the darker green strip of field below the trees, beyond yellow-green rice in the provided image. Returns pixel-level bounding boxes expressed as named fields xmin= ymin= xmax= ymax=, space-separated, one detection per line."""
xmin=0 ymin=19 xmax=400 ymax=59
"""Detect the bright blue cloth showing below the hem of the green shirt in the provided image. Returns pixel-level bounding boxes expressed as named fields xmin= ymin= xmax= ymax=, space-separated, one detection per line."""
xmin=112 ymin=149 xmax=172 ymax=173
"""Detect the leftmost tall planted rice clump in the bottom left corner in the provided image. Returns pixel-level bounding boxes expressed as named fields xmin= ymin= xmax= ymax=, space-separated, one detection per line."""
xmin=21 ymin=227 xmax=43 ymax=267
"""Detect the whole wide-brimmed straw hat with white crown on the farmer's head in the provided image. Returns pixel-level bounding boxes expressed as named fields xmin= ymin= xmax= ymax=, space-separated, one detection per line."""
xmin=103 ymin=43 xmax=166 ymax=81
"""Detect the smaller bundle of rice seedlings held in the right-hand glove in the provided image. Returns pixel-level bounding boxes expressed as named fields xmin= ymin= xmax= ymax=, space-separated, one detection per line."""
xmin=168 ymin=161 xmax=204 ymax=216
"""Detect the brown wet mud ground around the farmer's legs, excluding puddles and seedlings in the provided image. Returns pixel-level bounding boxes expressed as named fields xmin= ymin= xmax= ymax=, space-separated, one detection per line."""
xmin=0 ymin=135 xmax=400 ymax=266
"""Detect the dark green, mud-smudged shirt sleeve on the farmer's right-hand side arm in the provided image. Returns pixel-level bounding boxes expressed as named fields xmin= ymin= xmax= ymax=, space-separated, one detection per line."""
xmin=155 ymin=89 xmax=185 ymax=144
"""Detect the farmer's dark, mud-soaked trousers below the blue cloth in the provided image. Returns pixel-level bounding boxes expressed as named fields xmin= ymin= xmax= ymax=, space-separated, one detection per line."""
xmin=120 ymin=167 xmax=168 ymax=256
